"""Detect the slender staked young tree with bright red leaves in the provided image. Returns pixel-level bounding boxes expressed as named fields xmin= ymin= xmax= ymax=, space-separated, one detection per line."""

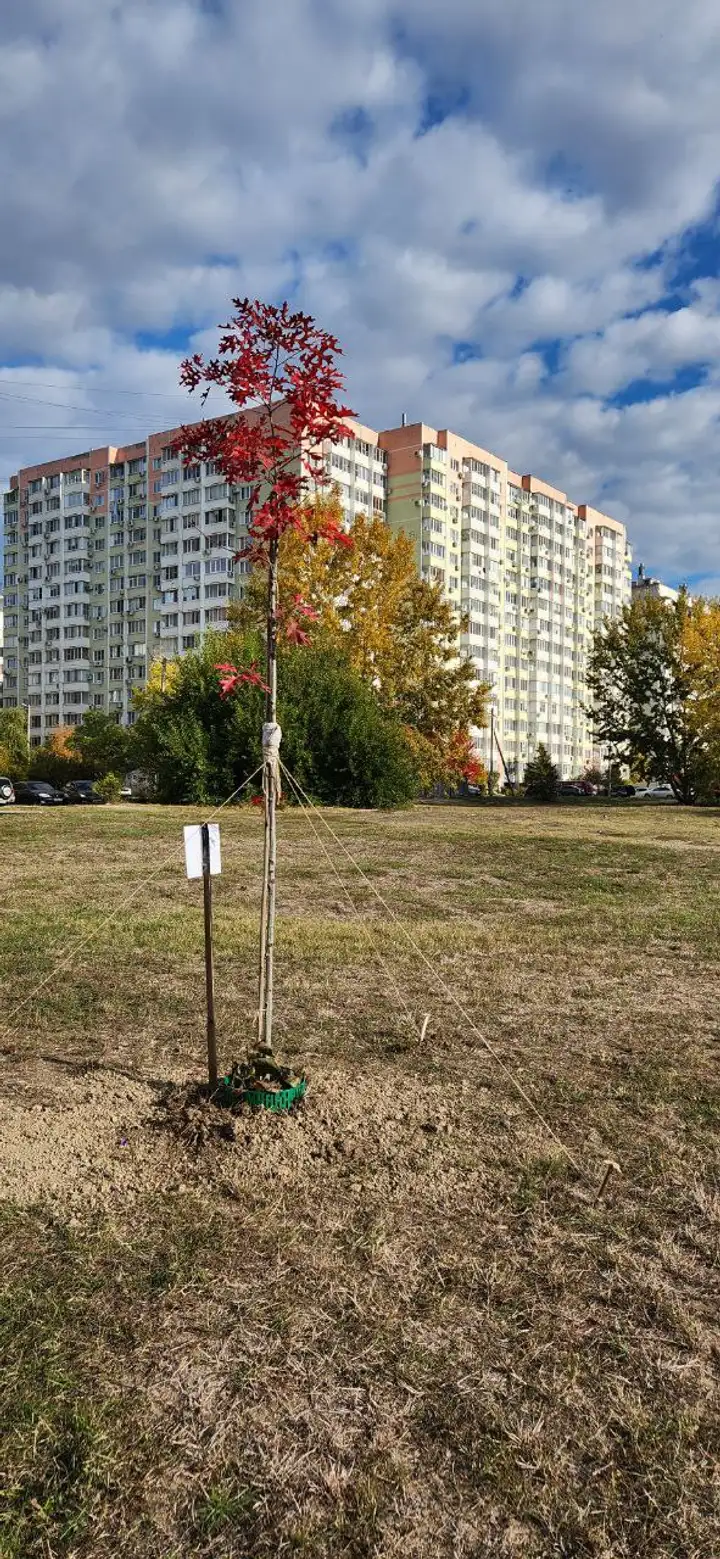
xmin=176 ymin=298 xmax=352 ymax=1054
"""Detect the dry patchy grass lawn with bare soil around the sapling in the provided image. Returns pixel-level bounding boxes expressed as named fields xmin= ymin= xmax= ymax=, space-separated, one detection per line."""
xmin=0 ymin=803 xmax=720 ymax=1559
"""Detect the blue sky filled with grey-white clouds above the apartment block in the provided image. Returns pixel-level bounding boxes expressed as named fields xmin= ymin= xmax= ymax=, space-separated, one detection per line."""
xmin=0 ymin=0 xmax=720 ymax=591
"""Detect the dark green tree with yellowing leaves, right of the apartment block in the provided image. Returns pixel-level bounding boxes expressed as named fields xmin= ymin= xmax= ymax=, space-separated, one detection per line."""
xmin=588 ymin=591 xmax=707 ymax=801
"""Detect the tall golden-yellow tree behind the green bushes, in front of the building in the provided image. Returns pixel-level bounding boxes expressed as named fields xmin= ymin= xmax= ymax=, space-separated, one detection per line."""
xmin=231 ymin=494 xmax=488 ymax=789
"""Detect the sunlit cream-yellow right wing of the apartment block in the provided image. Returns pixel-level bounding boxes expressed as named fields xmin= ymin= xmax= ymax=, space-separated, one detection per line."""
xmin=380 ymin=422 xmax=630 ymax=778
